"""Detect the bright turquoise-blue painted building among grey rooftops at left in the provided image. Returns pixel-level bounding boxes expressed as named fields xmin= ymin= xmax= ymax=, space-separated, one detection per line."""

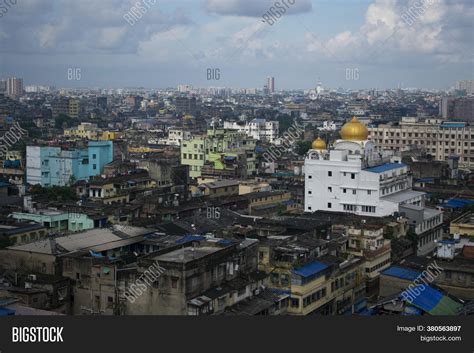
xmin=26 ymin=141 xmax=113 ymax=187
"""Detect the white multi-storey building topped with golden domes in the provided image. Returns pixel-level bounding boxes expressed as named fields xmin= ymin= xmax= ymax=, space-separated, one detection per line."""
xmin=305 ymin=118 xmax=442 ymax=254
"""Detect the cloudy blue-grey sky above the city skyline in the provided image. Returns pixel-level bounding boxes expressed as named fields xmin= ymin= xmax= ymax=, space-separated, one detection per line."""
xmin=0 ymin=0 xmax=474 ymax=89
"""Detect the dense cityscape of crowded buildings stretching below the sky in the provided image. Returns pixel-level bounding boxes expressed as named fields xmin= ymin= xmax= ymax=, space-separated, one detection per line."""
xmin=0 ymin=77 xmax=474 ymax=316
